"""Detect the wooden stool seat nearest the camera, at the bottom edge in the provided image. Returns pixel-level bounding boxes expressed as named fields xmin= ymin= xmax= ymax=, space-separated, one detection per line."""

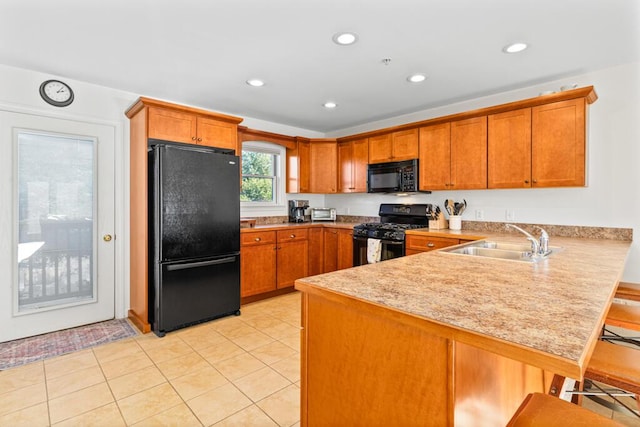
xmin=507 ymin=393 xmax=622 ymax=427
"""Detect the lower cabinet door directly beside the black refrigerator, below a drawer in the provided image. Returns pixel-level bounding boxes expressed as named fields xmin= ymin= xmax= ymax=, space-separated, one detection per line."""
xmin=240 ymin=243 xmax=277 ymax=297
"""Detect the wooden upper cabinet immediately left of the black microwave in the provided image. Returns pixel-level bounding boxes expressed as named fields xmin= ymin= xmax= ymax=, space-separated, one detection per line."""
xmin=338 ymin=138 xmax=369 ymax=193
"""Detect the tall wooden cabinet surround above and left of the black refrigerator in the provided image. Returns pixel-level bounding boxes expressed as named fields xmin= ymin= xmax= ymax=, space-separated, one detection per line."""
xmin=125 ymin=97 xmax=242 ymax=333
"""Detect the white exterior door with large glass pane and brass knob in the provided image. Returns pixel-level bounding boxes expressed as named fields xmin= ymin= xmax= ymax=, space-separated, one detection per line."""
xmin=0 ymin=110 xmax=114 ymax=342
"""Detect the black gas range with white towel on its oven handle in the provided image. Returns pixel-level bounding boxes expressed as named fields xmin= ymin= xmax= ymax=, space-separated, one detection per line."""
xmin=353 ymin=203 xmax=433 ymax=266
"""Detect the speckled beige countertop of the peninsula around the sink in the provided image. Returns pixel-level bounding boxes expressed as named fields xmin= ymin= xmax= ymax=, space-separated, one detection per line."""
xmin=296 ymin=234 xmax=631 ymax=378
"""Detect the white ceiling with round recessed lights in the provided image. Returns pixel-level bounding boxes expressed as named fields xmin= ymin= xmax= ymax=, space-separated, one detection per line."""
xmin=0 ymin=0 xmax=640 ymax=132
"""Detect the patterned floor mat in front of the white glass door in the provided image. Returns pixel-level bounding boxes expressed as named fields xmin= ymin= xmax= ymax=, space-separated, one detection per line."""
xmin=0 ymin=319 xmax=138 ymax=370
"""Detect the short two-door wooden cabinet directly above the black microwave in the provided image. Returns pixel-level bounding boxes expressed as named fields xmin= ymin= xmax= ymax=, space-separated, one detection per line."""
xmin=369 ymin=129 xmax=419 ymax=163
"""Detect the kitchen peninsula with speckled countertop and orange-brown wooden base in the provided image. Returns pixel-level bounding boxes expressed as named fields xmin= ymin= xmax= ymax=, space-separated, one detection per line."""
xmin=295 ymin=231 xmax=631 ymax=426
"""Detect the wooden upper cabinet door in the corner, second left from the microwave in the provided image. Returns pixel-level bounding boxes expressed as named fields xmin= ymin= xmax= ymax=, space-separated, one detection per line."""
xmin=309 ymin=139 xmax=338 ymax=194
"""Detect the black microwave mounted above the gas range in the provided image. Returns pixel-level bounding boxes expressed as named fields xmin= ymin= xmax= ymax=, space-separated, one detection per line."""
xmin=367 ymin=159 xmax=428 ymax=193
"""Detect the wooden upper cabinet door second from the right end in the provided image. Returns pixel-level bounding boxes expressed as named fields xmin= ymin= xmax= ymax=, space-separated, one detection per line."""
xmin=487 ymin=108 xmax=531 ymax=188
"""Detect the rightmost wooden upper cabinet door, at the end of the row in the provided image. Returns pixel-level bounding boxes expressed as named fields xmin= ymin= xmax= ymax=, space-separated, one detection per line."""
xmin=531 ymin=98 xmax=586 ymax=187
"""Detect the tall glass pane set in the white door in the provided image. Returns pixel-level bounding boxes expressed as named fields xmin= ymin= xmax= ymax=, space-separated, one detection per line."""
xmin=16 ymin=131 xmax=96 ymax=312
